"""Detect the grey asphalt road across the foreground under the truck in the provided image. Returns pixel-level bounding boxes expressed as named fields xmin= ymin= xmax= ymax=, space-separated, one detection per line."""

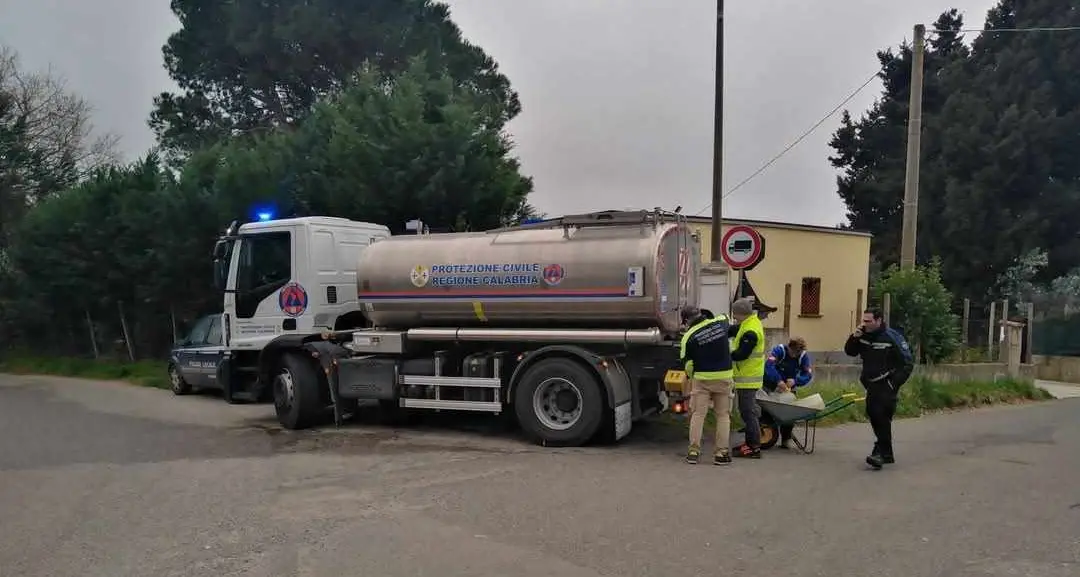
xmin=0 ymin=376 xmax=1080 ymax=577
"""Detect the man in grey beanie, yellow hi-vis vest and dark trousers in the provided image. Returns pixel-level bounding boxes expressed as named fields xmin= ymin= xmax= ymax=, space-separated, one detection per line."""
xmin=730 ymin=298 xmax=766 ymax=459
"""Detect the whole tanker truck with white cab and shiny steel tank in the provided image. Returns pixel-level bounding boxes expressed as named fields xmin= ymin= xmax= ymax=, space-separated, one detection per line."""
xmin=209 ymin=210 xmax=701 ymax=446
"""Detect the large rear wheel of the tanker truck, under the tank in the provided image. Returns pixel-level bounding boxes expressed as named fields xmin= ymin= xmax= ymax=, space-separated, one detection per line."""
xmin=514 ymin=358 xmax=606 ymax=446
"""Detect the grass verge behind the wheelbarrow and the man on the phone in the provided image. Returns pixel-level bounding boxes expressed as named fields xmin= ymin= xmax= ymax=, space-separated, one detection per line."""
xmin=673 ymin=377 xmax=1052 ymax=430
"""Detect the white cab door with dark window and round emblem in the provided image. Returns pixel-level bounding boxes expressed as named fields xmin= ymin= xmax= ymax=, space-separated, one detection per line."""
xmin=230 ymin=230 xmax=295 ymax=350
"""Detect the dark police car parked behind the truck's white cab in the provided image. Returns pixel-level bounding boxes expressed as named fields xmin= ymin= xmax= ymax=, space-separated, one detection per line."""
xmin=168 ymin=313 xmax=228 ymax=400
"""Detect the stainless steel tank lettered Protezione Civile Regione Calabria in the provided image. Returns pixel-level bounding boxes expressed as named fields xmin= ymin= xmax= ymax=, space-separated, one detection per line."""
xmin=356 ymin=213 xmax=701 ymax=333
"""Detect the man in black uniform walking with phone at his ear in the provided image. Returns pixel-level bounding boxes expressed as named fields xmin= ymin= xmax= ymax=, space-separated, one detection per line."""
xmin=843 ymin=309 xmax=915 ymax=469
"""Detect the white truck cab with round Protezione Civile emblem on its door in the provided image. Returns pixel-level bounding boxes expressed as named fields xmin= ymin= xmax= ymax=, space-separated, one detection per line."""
xmin=214 ymin=216 xmax=390 ymax=400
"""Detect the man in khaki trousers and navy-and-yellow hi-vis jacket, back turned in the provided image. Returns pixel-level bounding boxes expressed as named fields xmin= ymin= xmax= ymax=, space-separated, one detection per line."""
xmin=679 ymin=308 xmax=733 ymax=465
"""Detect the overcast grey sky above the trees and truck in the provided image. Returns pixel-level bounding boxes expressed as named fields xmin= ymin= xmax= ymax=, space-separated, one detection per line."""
xmin=0 ymin=0 xmax=994 ymax=226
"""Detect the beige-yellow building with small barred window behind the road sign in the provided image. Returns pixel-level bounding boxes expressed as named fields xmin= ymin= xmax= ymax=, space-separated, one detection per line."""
xmin=690 ymin=217 xmax=870 ymax=351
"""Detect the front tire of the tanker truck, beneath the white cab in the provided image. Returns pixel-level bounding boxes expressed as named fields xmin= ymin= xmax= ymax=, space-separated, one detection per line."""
xmin=272 ymin=352 xmax=326 ymax=430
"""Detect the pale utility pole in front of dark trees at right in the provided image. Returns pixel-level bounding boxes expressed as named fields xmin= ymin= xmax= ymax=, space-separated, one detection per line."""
xmin=900 ymin=24 xmax=927 ymax=270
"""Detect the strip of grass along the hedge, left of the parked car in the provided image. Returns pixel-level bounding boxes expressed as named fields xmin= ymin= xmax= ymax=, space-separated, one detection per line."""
xmin=0 ymin=354 xmax=170 ymax=389
